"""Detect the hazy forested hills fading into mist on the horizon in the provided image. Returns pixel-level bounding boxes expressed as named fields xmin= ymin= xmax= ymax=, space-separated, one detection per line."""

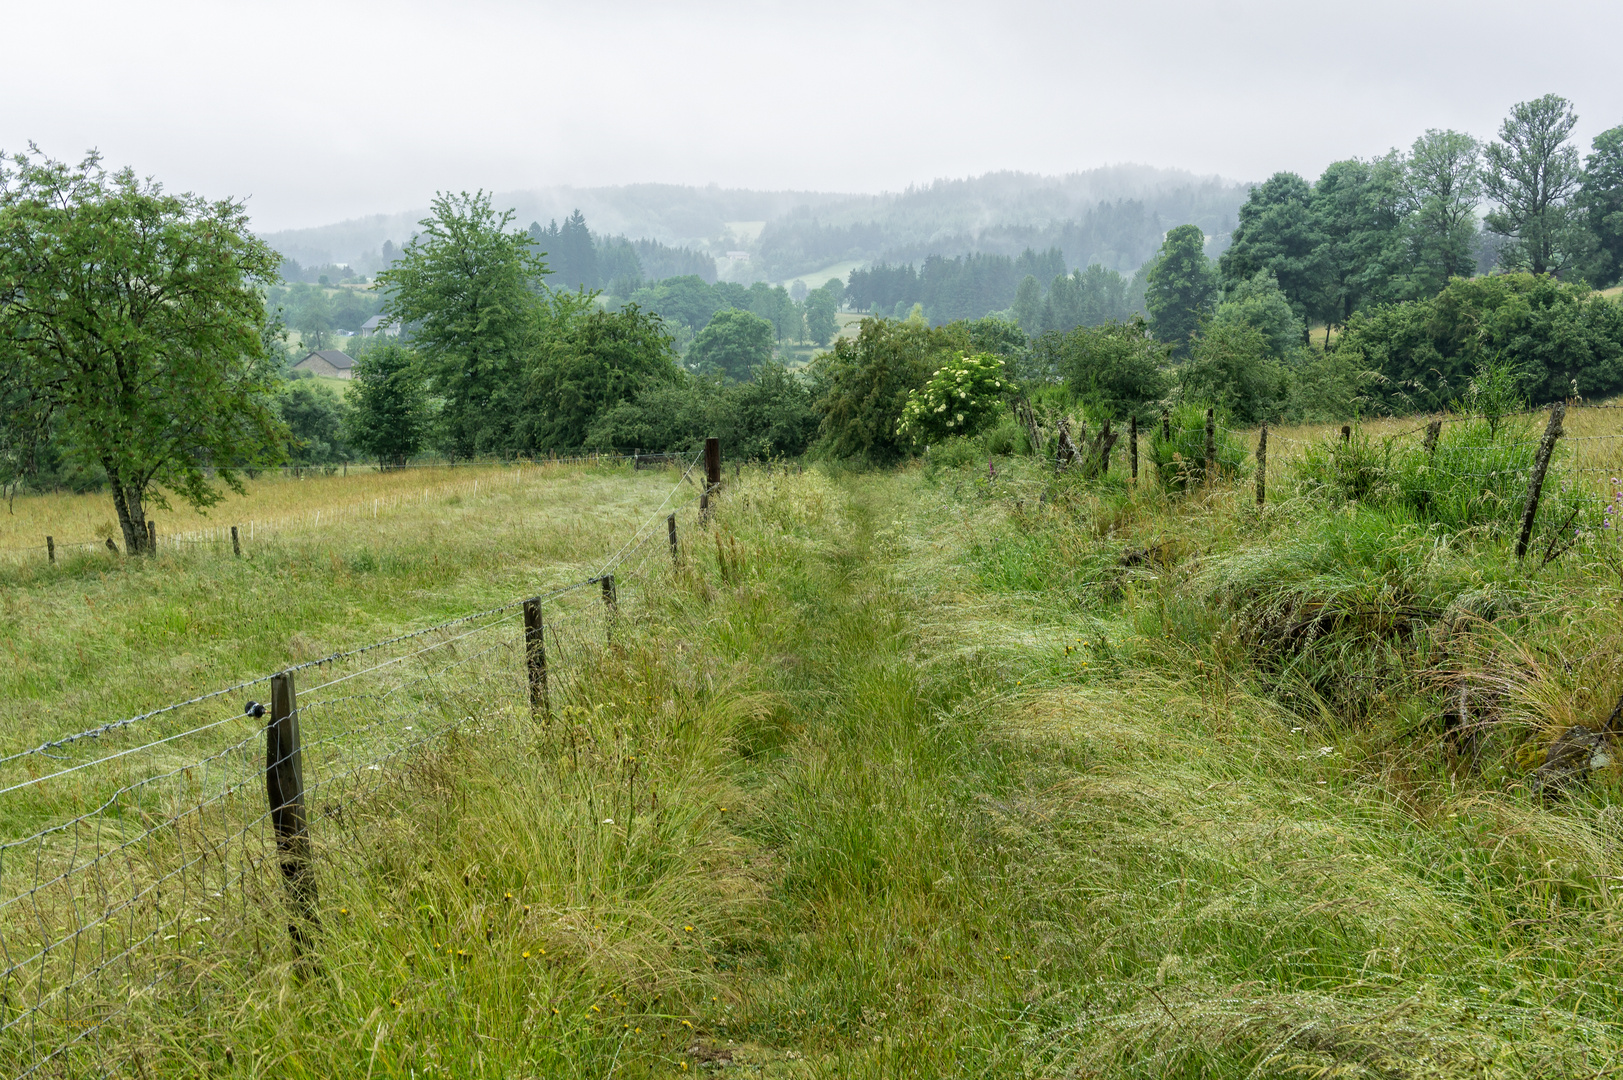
xmin=265 ymin=166 xmax=1248 ymax=281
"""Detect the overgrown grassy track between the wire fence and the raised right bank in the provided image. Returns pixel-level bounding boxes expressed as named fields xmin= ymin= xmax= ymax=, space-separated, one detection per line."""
xmin=3 ymin=461 xmax=1623 ymax=1078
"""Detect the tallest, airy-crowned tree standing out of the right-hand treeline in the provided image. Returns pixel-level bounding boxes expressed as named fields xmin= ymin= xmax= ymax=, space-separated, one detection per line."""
xmin=1483 ymin=94 xmax=1592 ymax=274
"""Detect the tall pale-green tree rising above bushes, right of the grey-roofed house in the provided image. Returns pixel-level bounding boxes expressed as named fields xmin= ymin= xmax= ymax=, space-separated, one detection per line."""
xmin=378 ymin=192 xmax=550 ymax=456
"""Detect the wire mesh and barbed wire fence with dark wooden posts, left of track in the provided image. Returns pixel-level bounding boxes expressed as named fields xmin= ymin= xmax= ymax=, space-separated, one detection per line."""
xmin=0 ymin=440 xmax=721 ymax=1080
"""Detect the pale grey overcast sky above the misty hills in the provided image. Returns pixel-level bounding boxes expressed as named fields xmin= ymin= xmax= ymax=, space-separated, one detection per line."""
xmin=0 ymin=0 xmax=1623 ymax=229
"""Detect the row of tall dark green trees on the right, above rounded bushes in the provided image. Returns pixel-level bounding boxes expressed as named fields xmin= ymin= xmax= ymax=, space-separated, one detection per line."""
xmin=1219 ymin=94 xmax=1623 ymax=326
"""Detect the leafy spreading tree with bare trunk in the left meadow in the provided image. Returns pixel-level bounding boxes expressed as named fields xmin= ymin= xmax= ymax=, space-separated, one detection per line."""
xmin=0 ymin=151 xmax=284 ymax=552
